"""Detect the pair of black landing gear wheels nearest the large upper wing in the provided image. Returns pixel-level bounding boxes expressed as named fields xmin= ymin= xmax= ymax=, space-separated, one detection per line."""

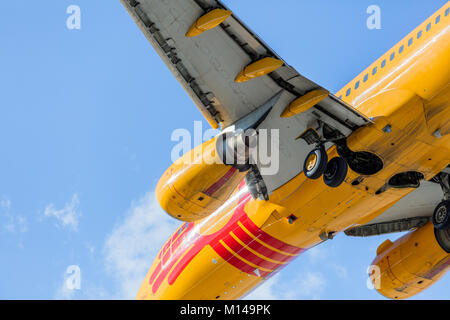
xmin=303 ymin=145 xmax=348 ymax=188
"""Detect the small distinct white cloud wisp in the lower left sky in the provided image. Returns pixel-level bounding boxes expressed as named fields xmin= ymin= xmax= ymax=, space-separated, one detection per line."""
xmin=44 ymin=194 xmax=82 ymax=231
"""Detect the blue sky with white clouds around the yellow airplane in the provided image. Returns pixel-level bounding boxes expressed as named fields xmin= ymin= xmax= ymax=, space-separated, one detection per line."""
xmin=0 ymin=0 xmax=450 ymax=299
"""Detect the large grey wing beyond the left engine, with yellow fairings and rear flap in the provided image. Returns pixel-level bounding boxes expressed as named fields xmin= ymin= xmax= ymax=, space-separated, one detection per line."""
xmin=121 ymin=0 xmax=370 ymax=131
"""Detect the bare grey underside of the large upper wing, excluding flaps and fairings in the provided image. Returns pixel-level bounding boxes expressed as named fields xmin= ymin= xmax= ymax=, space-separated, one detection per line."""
xmin=122 ymin=0 xmax=280 ymax=126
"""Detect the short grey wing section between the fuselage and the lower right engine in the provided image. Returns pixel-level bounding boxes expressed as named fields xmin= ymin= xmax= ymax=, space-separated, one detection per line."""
xmin=345 ymin=181 xmax=442 ymax=237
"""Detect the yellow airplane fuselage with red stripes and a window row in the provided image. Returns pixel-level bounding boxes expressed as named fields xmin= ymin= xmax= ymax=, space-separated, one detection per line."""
xmin=137 ymin=4 xmax=450 ymax=299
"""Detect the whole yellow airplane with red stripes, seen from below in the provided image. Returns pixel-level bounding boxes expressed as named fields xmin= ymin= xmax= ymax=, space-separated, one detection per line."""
xmin=121 ymin=0 xmax=450 ymax=300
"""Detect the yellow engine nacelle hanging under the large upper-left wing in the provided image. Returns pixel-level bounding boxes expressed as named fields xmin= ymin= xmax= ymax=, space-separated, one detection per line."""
xmin=156 ymin=138 xmax=245 ymax=222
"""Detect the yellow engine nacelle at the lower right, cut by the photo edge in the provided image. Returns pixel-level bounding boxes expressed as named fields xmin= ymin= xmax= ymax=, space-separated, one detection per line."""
xmin=369 ymin=222 xmax=450 ymax=299
